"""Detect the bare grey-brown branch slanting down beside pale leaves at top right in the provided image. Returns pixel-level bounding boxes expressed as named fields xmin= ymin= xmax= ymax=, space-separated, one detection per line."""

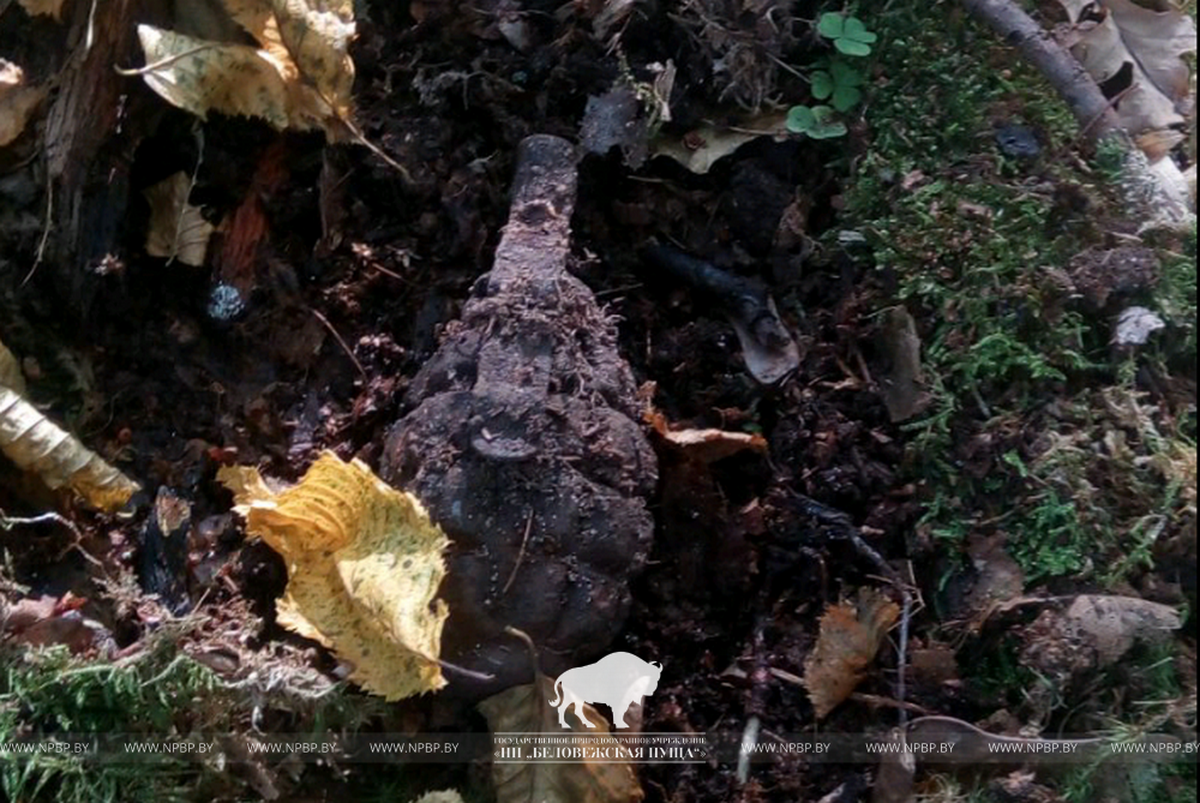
xmin=962 ymin=0 xmax=1122 ymax=142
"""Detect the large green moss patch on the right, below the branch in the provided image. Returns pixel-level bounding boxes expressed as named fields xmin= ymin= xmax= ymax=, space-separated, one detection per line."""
xmin=829 ymin=2 xmax=1195 ymax=583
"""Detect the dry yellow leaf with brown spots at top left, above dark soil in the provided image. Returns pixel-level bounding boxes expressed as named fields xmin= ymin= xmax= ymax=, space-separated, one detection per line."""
xmin=138 ymin=0 xmax=354 ymax=139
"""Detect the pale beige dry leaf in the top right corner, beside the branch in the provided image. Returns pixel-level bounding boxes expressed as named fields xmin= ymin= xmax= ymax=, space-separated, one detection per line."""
xmin=1060 ymin=0 xmax=1196 ymax=134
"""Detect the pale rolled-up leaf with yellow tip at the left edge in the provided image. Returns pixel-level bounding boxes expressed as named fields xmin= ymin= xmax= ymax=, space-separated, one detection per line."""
xmin=0 ymin=388 xmax=139 ymax=513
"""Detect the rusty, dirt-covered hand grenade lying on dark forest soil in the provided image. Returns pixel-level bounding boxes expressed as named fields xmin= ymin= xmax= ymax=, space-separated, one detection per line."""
xmin=383 ymin=136 xmax=658 ymax=696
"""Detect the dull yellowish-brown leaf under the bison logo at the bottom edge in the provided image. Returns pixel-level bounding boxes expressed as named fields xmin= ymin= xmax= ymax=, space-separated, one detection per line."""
xmin=479 ymin=675 xmax=644 ymax=803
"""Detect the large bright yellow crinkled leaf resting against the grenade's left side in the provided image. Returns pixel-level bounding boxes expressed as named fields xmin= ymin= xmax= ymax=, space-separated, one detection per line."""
xmin=217 ymin=451 xmax=450 ymax=700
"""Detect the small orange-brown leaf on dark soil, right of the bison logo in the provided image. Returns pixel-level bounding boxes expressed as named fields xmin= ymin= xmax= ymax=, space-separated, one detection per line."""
xmin=804 ymin=588 xmax=900 ymax=719
